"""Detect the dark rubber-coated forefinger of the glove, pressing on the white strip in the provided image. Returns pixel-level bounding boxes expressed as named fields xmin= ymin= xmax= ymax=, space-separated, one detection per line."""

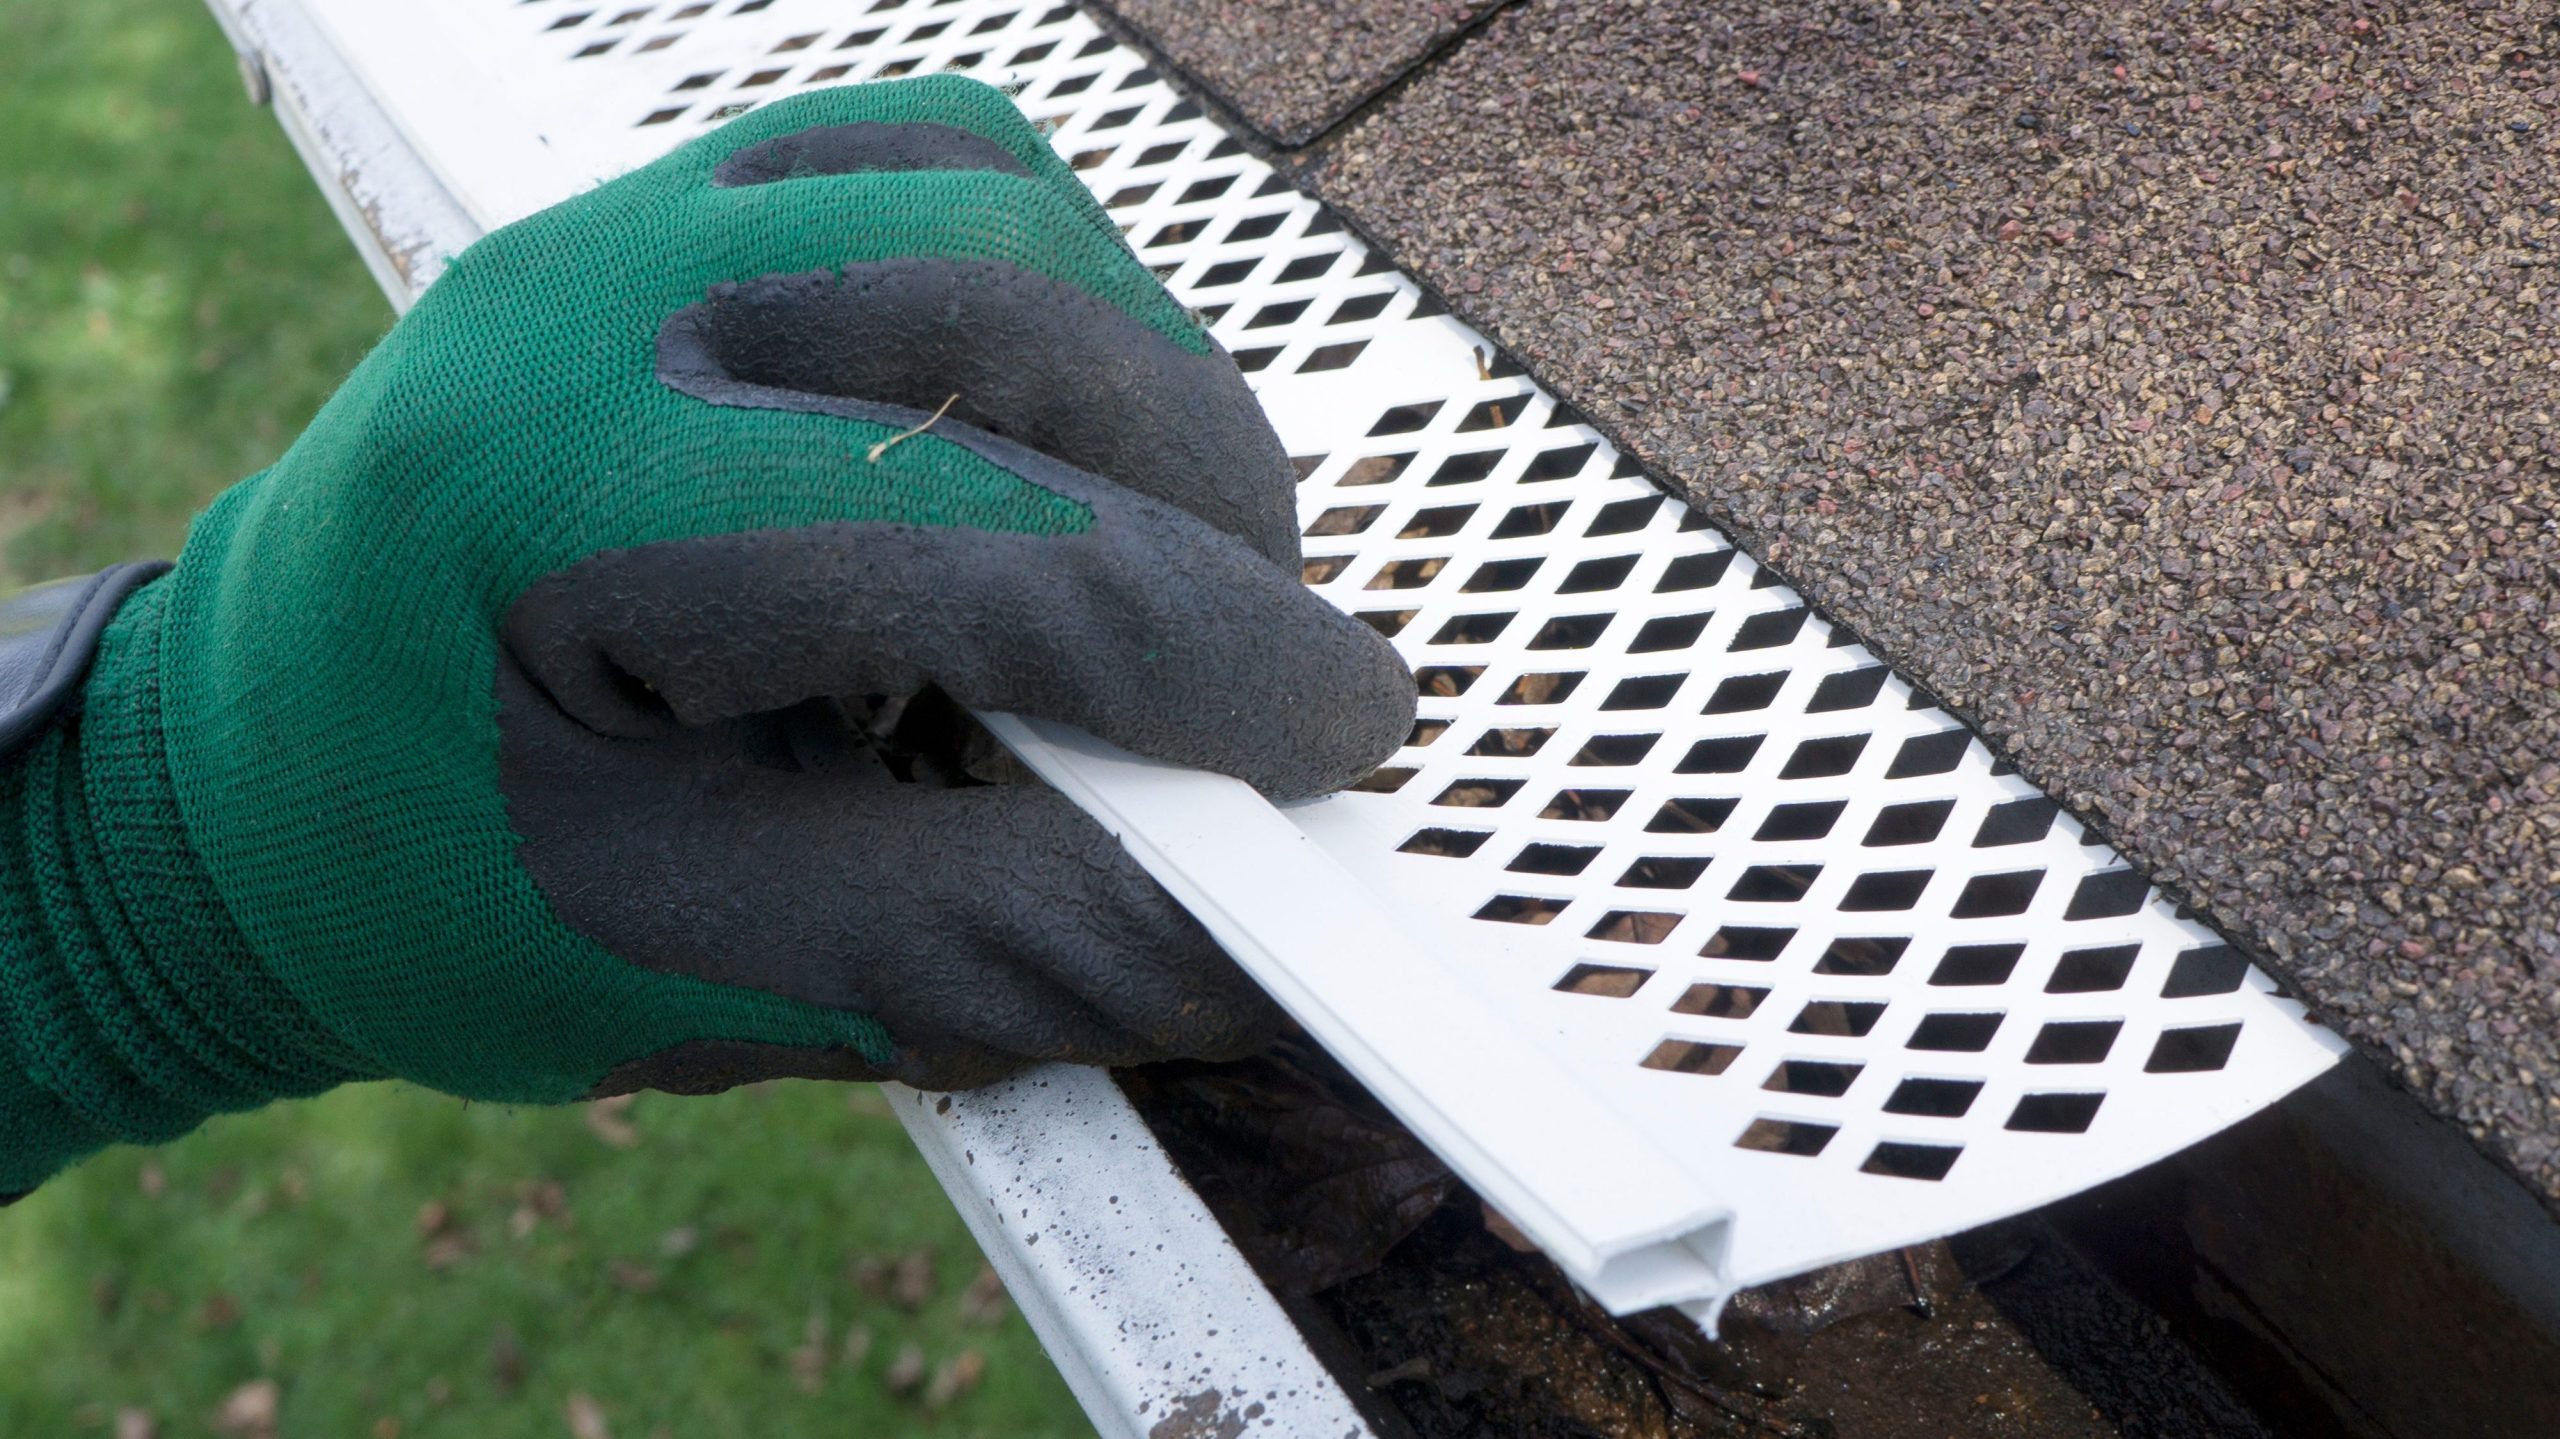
xmin=504 ymin=430 xmax=1416 ymax=799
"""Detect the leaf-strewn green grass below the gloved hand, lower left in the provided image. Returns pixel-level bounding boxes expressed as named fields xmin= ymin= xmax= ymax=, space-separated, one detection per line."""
xmin=0 ymin=1083 xmax=1085 ymax=1439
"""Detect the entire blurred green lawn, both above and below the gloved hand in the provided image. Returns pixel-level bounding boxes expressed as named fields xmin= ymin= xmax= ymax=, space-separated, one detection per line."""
xmin=0 ymin=0 xmax=1091 ymax=1439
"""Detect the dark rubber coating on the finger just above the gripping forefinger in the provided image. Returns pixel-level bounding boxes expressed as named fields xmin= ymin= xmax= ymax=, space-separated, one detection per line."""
xmin=658 ymin=259 xmax=1298 ymax=560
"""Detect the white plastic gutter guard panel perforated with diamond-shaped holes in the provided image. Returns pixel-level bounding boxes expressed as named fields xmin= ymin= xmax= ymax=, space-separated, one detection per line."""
xmin=294 ymin=0 xmax=2337 ymax=1298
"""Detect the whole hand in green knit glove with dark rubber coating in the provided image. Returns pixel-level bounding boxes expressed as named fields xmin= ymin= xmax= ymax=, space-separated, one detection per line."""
xmin=0 ymin=77 xmax=1413 ymax=1191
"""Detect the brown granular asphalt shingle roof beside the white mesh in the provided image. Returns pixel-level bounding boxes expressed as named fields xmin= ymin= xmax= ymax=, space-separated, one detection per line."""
xmin=1119 ymin=0 xmax=2560 ymax=1196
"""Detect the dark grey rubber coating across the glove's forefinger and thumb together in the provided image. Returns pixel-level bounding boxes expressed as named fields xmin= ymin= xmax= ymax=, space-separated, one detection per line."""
xmin=499 ymin=453 xmax=1413 ymax=1083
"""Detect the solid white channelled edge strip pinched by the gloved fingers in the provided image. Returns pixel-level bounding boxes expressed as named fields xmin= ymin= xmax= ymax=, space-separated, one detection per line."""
xmin=988 ymin=714 xmax=1733 ymax=1321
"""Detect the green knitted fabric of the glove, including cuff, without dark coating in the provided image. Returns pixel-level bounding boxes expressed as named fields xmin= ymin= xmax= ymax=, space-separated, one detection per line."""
xmin=0 ymin=77 xmax=1208 ymax=1193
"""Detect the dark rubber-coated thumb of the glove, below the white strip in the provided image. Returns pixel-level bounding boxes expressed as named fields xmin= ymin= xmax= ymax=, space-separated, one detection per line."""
xmin=499 ymin=666 xmax=1300 ymax=1083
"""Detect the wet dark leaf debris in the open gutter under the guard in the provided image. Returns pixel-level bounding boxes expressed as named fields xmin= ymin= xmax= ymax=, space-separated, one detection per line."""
xmin=1116 ymin=1040 xmax=2117 ymax=1439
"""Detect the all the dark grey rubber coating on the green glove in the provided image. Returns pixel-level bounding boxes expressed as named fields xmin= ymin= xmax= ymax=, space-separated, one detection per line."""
xmin=497 ymin=125 xmax=1413 ymax=1093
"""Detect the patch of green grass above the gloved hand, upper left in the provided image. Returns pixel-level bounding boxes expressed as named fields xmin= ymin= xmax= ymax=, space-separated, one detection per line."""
xmin=0 ymin=0 xmax=389 ymax=581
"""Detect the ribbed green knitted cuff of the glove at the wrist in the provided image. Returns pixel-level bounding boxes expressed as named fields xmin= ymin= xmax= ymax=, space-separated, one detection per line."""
xmin=0 ymin=570 xmax=364 ymax=1193
